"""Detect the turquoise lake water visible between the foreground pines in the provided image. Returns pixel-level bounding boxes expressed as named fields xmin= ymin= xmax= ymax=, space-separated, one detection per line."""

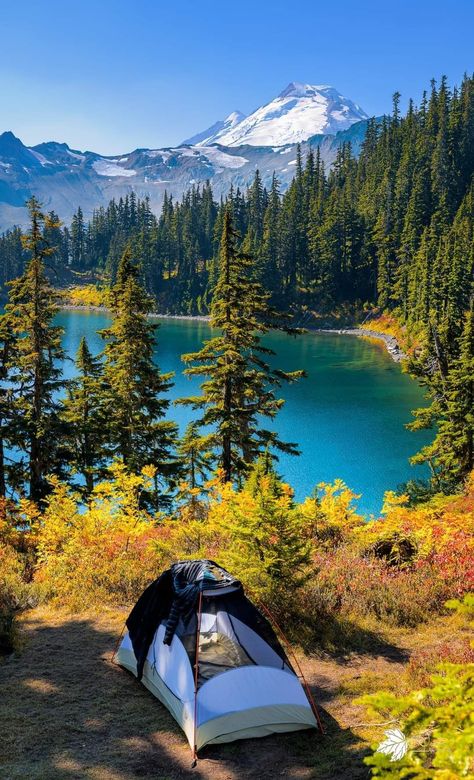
xmin=57 ymin=311 xmax=430 ymax=514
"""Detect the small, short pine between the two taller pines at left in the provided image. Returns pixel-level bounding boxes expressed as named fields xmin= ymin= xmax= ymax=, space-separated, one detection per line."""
xmin=62 ymin=338 xmax=107 ymax=496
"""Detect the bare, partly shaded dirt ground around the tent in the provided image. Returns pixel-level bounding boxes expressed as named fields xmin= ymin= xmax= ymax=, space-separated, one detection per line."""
xmin=0 ymin=608 xmax=454 ymax=780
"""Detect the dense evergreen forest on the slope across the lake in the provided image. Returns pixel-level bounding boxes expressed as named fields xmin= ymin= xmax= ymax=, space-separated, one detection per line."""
xmin=0 ymin=76 xmax=474 ymax=322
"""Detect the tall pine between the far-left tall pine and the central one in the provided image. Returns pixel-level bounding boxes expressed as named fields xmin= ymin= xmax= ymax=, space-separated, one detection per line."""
xmin=101 ymin=249 xmax=177 ymax=506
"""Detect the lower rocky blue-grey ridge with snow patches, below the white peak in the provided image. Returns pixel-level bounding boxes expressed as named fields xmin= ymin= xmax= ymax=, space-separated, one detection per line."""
xmin=0 ymin=116 xmax=367 ymax=232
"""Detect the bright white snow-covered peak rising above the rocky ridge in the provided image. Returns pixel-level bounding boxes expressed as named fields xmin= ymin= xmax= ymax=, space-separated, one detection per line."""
xmin=189 ymin=81 xmax=367 ymax=146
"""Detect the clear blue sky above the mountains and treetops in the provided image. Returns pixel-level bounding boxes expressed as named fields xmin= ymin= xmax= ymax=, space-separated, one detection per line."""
xmin=0 ymin=0 xmax=474 ymax=154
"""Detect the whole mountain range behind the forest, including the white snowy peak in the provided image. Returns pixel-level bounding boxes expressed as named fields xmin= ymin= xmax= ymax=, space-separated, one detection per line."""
xmin=0 ymin=82 xmax=367 ymax=231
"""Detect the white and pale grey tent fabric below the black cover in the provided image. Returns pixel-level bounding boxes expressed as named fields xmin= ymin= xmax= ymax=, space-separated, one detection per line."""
xmin=117 ymin=599 xmax=317 ymax=750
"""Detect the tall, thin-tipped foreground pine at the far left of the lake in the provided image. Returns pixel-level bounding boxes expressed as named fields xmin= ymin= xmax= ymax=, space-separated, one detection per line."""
xmin=2 ymin=197 xmax=66 ymax=502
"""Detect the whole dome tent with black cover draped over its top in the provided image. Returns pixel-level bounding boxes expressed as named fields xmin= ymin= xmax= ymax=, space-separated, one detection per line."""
xmin=117 ymin=560 xmax=320 ymax=757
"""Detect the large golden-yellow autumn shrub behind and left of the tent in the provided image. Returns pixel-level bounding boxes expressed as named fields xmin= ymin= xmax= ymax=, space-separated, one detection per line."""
xmin=35 ymin=462 xmax=161 ymax=609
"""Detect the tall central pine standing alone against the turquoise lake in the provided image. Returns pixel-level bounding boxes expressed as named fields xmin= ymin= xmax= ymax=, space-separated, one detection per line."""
xmin=180 ymin=208 xmax=303 ymax=481
